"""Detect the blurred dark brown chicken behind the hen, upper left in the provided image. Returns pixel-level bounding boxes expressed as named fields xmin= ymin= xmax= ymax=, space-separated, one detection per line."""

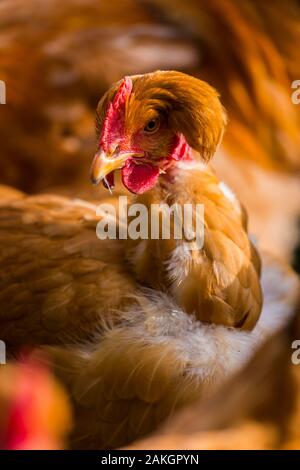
xmin=0 ymin=0 xmax=197 ymax=194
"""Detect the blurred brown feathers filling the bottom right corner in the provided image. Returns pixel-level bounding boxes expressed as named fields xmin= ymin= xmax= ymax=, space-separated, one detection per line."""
xmin=132 ymin=298 xmax=300 ymax=450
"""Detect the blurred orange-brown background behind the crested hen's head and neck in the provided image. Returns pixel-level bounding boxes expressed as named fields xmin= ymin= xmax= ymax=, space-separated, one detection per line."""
xmin=0 ymin=0 xmax=300 ymax=269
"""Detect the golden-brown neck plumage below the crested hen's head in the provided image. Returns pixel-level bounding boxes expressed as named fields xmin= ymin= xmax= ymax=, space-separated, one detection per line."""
xmin=127 ymin=169 xmax=262 ymax=329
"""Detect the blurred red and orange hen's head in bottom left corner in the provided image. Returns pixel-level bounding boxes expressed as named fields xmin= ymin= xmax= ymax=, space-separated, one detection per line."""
xmin=0 ymin=359 xmax=71 ymax=450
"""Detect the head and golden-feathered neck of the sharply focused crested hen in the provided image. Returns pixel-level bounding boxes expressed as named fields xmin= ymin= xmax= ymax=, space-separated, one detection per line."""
xmin=92 ymin=71 xmax=262 ymax=329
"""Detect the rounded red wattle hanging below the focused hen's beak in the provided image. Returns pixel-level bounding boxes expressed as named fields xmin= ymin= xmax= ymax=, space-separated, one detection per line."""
xmin=121 ymin=159 xmax=159 ymax=194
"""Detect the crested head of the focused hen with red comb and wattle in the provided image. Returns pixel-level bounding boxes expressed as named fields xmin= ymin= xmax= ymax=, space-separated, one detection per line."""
xmin=91 ymin=71 xmax=226 ymax=194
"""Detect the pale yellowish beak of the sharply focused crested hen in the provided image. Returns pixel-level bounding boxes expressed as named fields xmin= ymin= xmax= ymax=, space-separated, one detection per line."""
xmin=91 ymin=150 xmax=131 ymax=185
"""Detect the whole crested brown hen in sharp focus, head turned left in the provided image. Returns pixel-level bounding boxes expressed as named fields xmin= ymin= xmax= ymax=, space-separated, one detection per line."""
xmin=0 ymin=72 xmax=298 ymax=448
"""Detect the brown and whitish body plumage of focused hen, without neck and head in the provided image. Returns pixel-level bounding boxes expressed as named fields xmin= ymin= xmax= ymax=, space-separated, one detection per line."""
xmin=1 ymin=194 xmax=299 ymax=449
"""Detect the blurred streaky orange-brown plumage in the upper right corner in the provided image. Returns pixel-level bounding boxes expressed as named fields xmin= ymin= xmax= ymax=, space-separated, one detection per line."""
xmin=143 ymin=0 xmax=300 ymax=172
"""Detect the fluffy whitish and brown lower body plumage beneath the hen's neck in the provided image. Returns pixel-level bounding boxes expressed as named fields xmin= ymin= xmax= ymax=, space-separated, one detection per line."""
xmin=43 ymin=256 xmax=299 ymax=449
